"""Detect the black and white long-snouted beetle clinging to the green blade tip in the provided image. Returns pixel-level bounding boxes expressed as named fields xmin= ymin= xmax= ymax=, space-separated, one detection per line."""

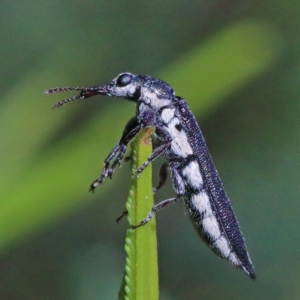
xmin=46 ymin=72 xmax=255 ymax=279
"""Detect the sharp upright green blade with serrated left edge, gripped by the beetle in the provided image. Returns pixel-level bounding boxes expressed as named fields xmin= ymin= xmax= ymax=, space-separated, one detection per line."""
xmin=120 ymin=129 xmax=158 ymax=300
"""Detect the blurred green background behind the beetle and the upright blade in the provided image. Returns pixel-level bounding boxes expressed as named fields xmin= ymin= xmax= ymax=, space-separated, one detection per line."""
xmin=0 ymin=0 xmax=300 ymax=300
